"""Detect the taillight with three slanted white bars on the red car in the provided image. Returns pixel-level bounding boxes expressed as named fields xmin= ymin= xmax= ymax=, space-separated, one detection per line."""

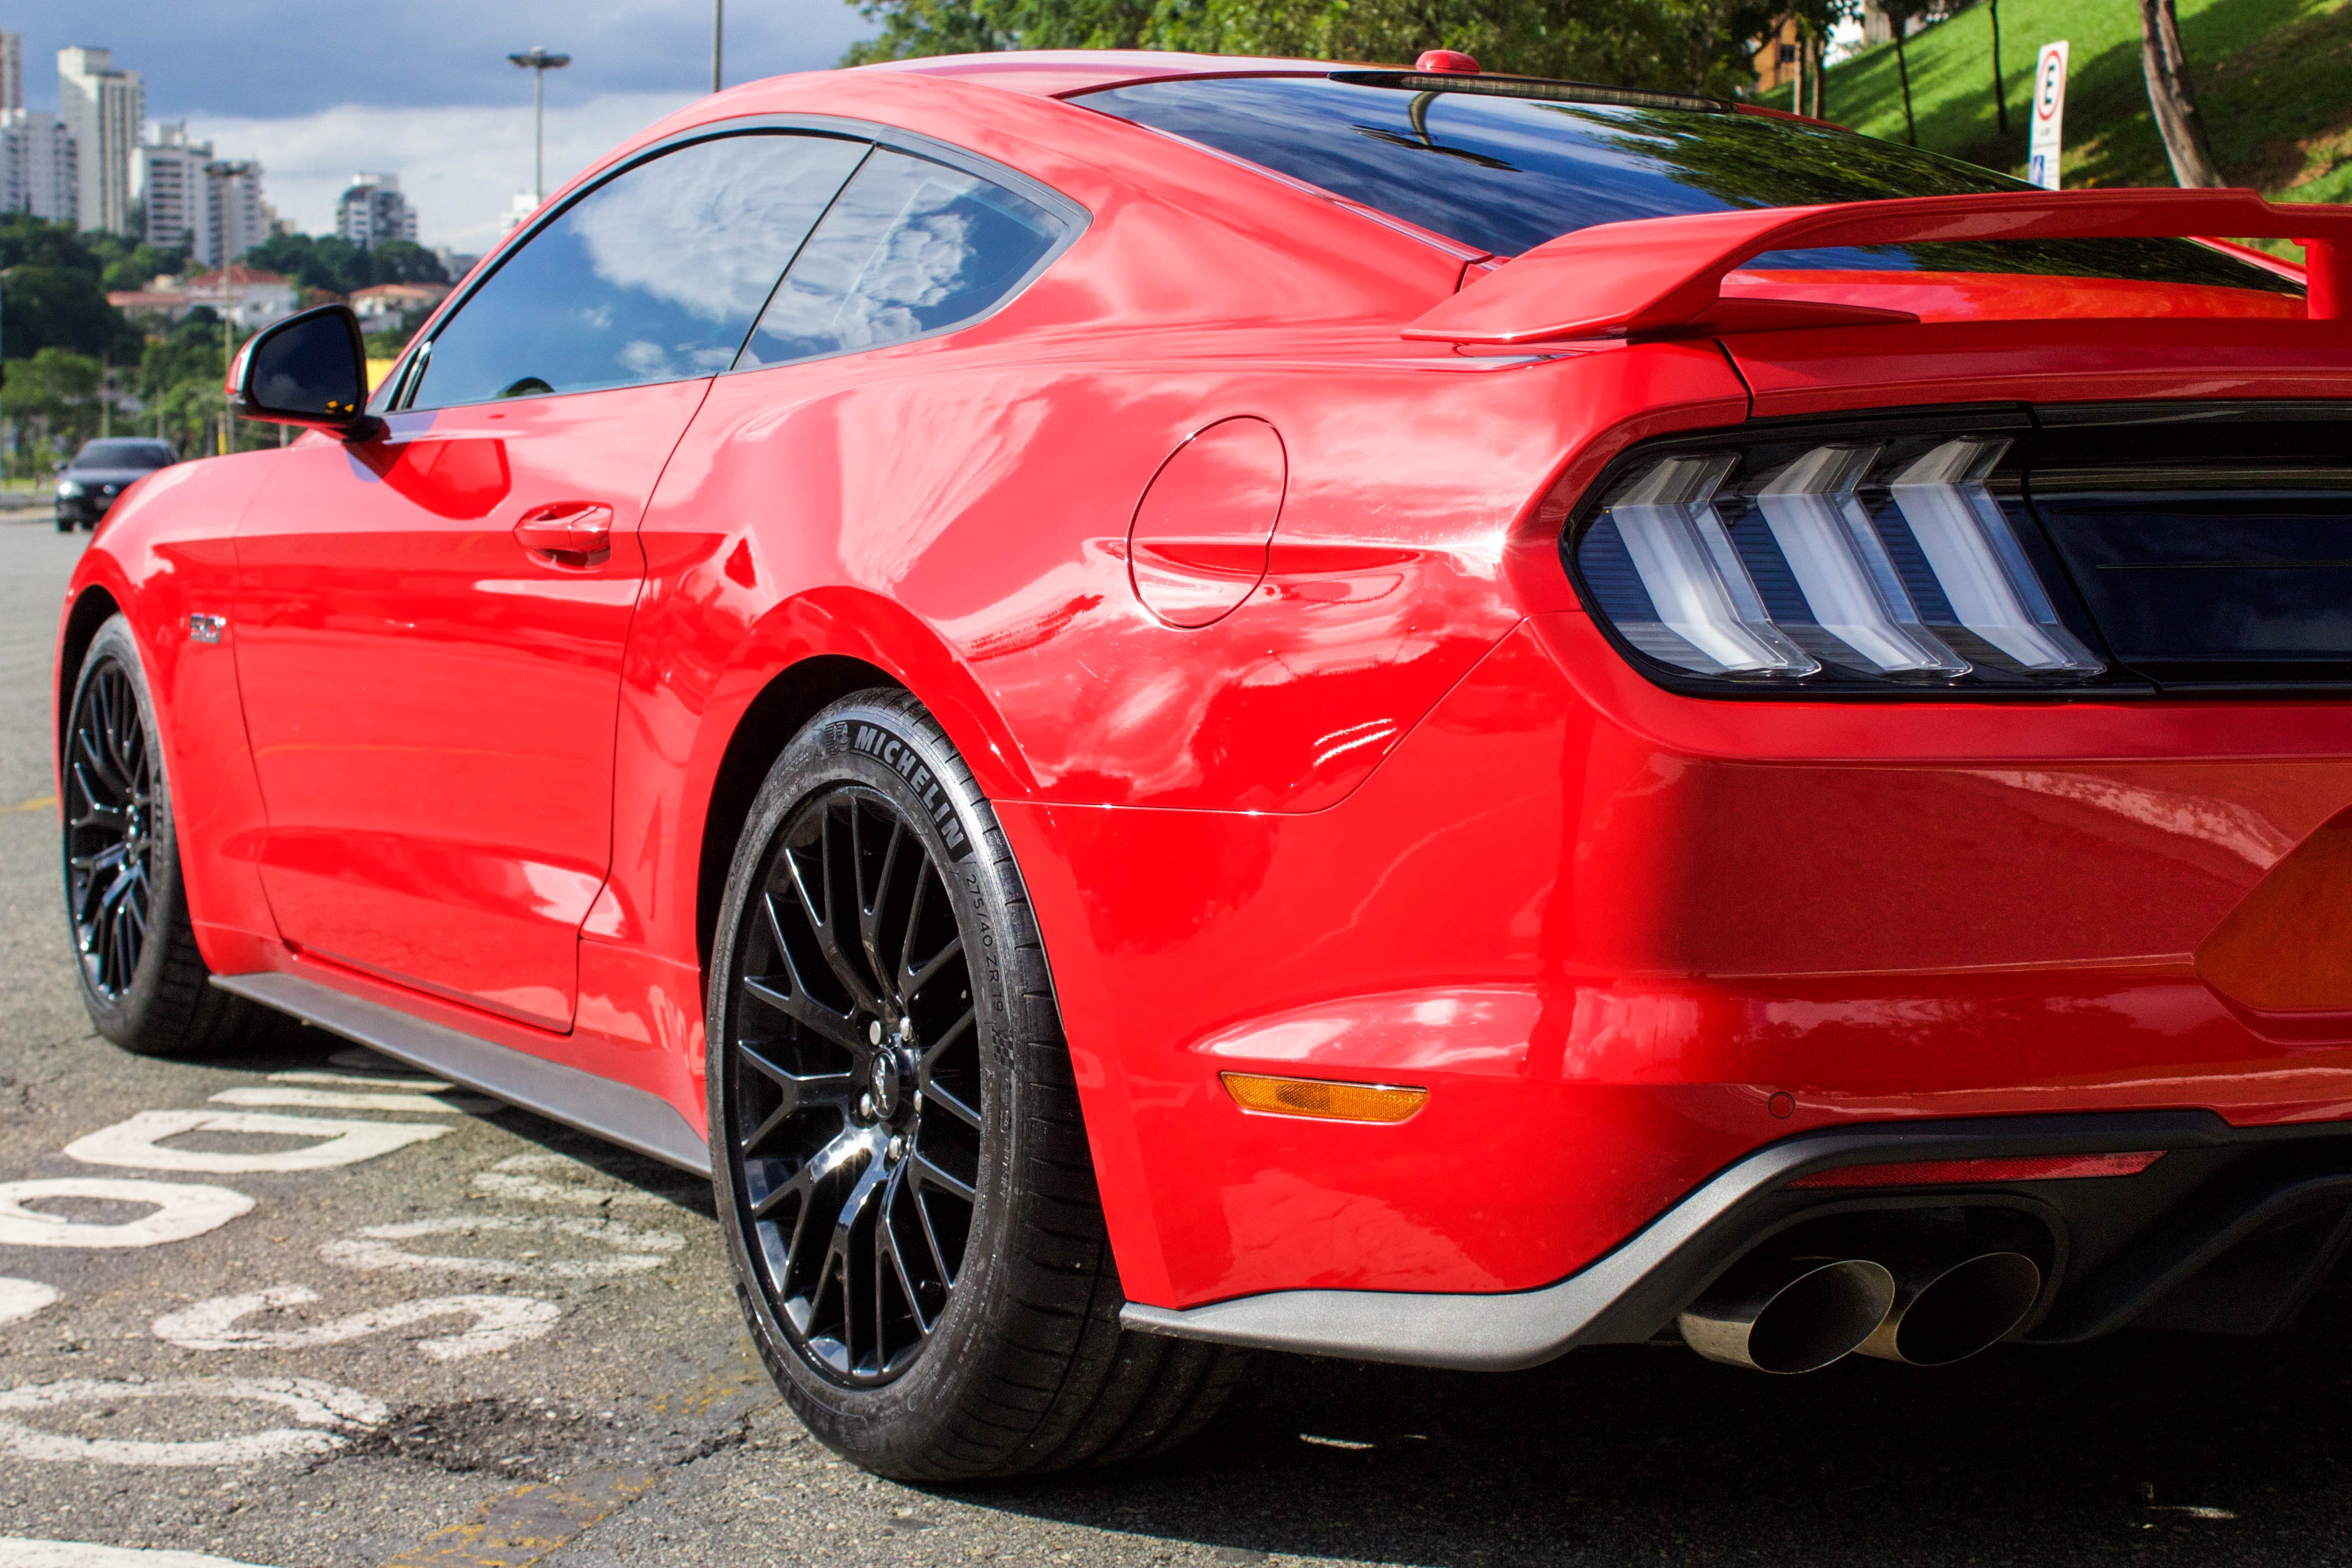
xmin=1564 ymin=426 xmax=2108 ymax=691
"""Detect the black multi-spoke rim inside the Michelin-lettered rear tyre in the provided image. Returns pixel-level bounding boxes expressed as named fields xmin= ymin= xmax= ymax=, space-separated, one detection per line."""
xmin=726 ymin=783 xmax=981 ymax=1384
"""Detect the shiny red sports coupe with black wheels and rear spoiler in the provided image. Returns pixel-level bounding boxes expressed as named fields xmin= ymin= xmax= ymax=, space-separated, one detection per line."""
xmin=56 ymin=54 xmax=2352 ymax=1478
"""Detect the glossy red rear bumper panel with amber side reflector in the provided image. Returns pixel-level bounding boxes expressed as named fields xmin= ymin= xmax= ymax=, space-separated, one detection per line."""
xmin=1000 ymin=614 xmax=2352 ymax=1316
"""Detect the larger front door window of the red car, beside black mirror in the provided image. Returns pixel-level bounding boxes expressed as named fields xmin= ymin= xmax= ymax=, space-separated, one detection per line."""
xmin=409 ymin=134 xmax=868 ymax=409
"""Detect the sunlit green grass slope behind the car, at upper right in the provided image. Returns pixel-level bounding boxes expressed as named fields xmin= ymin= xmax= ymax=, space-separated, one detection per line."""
xmin=1774 ymin=0 xmax=2352 ymax=202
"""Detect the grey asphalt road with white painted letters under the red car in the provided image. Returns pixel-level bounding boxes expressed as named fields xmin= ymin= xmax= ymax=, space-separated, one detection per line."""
xmin=0 ymin=517 xmax=2352 ymax=1568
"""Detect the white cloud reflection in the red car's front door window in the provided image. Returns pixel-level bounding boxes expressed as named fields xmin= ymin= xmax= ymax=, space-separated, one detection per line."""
xmin=569 ymin=137 xmax=870 ymax=322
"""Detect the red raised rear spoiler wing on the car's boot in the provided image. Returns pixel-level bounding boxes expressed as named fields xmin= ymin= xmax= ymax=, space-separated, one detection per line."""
xmin=1404 ymin=190 xmax=2352 ymax=343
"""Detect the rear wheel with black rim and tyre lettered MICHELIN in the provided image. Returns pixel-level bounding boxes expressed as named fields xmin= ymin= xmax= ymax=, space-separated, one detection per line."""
xmin=708 ymin=691 xmax=1237 ymax=1481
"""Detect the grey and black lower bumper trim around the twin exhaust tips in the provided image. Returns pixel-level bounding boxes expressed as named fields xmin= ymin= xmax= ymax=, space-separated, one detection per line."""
xmin=1120 ymin=1112 xmax=2352 ymax=1371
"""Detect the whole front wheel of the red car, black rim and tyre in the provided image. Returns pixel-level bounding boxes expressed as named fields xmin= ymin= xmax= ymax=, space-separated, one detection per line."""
xmin=59 ymin=616 xmax=278 ymax=1055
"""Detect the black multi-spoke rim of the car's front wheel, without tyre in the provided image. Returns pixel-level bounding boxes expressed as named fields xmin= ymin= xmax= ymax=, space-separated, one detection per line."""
xmin=64 ymin=658 xmax=155 ymax=1006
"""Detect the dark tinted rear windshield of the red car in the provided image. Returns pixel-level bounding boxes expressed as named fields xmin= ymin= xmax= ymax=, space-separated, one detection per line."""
xmin=1075 ymin=73 xmax=2300 ymax=294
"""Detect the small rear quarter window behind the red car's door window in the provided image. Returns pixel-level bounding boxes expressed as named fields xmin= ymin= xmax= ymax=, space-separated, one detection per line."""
xmin=736 ymin=150 xmax=1063 ymax=369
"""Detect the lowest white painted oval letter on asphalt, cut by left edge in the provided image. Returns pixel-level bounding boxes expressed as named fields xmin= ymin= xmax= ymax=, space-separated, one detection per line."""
xmin=0 ymin=1378 xmax=393 ymax=1469
